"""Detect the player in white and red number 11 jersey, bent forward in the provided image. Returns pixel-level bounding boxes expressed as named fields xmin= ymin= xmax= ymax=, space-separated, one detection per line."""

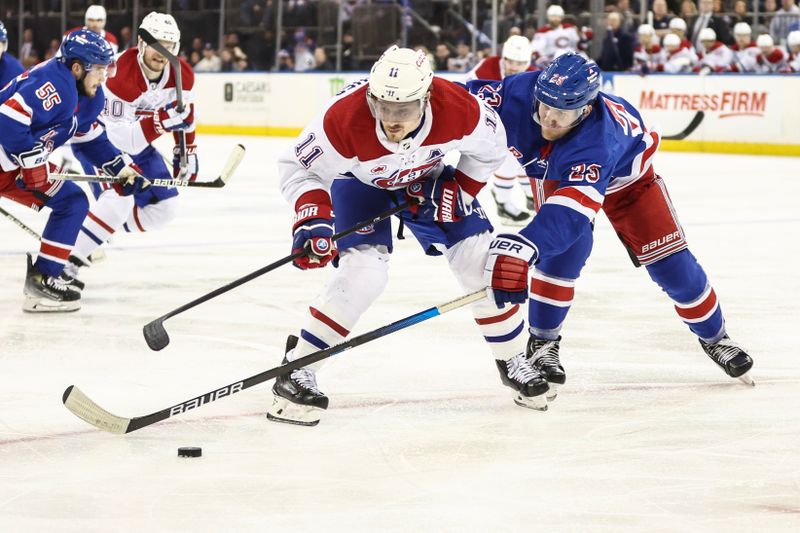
xmin=267 ymin=46 xmax=548 ymax=425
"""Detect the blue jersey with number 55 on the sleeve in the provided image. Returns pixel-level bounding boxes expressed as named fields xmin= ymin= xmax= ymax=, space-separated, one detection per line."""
xmin=0 ymin=60 xmax=120 ymax=171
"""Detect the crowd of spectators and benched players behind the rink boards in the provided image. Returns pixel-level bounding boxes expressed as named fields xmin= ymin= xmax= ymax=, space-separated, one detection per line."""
xmin=0 ymin=0 xmax=800 ymax=74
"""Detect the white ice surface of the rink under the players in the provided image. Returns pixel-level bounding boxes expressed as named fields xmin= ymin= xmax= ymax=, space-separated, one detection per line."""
xmin=0 ymin=136 xmax=800 ymax=532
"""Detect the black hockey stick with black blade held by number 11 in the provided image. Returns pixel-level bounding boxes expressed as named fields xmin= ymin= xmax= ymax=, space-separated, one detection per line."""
xmin=142 ymin=197 xmax=411 ymax=351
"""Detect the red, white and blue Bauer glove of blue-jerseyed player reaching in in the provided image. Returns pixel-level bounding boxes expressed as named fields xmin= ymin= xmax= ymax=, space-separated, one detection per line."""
xmin=483 ymin=233 xmax=539 ymax=309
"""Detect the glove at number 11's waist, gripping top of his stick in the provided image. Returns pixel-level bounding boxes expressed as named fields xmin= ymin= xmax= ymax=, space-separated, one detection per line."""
xmin=406 ymin=165 xmax=472 ymax=222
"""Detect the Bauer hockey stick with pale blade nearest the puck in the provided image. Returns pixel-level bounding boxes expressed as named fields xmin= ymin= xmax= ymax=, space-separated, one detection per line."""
xmin=62 ymin=289 xmax=486 ymax=435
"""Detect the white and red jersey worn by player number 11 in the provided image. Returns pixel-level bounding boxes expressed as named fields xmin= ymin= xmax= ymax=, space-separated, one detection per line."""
xmin=278 ymin=78 xmax=508 ymax=205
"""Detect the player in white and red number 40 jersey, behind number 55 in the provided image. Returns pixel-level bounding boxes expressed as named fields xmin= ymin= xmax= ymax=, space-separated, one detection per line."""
xmin=68 ymin=12 xmax=198 ymax=275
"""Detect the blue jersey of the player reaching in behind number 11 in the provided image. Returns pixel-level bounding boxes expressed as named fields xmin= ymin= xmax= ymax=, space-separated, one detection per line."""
xmin=468 ymin=72 xmax=660 ymax=258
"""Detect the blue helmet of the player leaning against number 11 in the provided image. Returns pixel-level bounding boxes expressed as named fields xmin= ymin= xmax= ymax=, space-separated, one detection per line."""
xmin=533 ymin=52 xmax=600 ymax=109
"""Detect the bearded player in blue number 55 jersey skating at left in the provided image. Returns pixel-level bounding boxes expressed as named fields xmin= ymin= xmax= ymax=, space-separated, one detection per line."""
xmin=0 ymin=30 xmax=145 ymax=312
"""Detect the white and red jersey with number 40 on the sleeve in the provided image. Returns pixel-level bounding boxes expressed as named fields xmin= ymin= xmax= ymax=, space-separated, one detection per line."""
xmin=99 ymin=48 xmax=194 ymax=155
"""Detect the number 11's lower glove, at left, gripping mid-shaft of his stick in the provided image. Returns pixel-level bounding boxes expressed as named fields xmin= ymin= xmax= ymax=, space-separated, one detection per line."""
xmin=292 ymin=189 xmax=338 ymax=270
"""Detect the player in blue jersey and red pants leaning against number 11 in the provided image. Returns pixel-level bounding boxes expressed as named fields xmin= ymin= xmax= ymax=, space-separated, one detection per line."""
xmin=470 ymin=54 xmax=753 ymax=399
